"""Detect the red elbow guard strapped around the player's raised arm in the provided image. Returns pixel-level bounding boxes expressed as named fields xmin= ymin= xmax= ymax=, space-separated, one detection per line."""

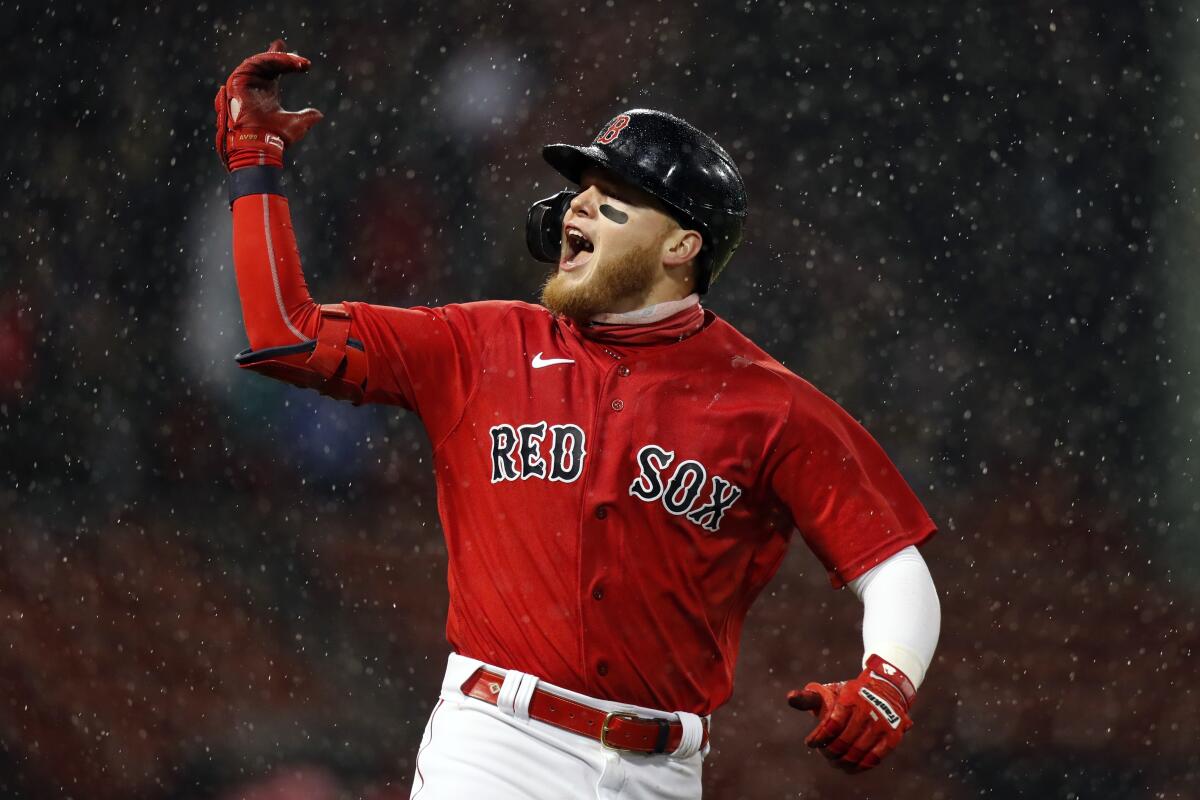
xmin=234 ymin=303 xmax=367 ymax=405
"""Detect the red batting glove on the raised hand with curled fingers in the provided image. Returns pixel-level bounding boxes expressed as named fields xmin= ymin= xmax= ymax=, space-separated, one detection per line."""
xmin=212 ymin=38 xmax=323 ymax=172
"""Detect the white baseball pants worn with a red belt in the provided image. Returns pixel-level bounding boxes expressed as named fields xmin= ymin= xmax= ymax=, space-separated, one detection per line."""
xmin=410 ymin=654 xmax=707 ymax=800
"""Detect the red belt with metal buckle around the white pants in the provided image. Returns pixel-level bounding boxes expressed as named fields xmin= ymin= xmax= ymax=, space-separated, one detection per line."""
xmin=462 ymin=667 xmax=708 ymax=753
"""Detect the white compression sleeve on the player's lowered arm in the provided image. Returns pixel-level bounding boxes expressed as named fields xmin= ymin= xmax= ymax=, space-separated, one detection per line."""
xmin=848 ymin=546 xmax=942 ymax=686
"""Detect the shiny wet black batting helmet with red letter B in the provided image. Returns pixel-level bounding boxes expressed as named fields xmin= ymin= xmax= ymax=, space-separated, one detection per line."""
xmin=526 ymin=108 xmax=746 ymax=294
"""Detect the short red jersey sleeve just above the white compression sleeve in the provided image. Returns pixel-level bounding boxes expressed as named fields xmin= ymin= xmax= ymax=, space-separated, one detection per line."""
xmin=770 ymin=384 xmax=936 ymax=588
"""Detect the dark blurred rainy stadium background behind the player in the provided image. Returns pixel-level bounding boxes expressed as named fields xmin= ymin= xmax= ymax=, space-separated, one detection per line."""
xmin=0 ymin=0 xmax=1200 ymax=800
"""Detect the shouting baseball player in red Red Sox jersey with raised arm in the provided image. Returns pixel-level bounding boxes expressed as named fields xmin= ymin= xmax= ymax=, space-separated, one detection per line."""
xmin=216 ymin=42 xmax=940 ymax=800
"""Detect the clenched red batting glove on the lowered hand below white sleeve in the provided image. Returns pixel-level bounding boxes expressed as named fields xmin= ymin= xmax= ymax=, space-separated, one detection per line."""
xmin=787 ymin=655 xmax=917 ymax=774
